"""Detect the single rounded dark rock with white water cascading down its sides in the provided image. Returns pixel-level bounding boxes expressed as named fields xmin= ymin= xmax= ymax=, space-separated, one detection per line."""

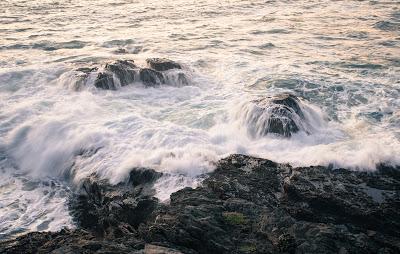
xmin=249 ymin=94 xmax=305 ymax=137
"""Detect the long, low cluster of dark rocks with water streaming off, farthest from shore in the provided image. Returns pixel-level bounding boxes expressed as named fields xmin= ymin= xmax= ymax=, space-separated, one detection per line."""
xmin=76 ymin=58 xmax=189 ymax=90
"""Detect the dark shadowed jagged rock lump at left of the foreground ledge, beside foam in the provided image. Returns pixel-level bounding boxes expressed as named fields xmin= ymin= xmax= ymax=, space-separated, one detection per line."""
xmin=70 ymin=168 xmax=161 ymax=237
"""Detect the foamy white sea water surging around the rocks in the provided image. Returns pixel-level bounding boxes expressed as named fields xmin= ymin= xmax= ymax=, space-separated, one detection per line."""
xmin=0 ymin=0 xmax=400 ymax=239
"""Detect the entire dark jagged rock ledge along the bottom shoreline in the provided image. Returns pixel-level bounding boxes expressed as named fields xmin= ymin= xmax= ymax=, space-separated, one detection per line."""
xmin=0 ymin=155 xmax=400 ymax=253
